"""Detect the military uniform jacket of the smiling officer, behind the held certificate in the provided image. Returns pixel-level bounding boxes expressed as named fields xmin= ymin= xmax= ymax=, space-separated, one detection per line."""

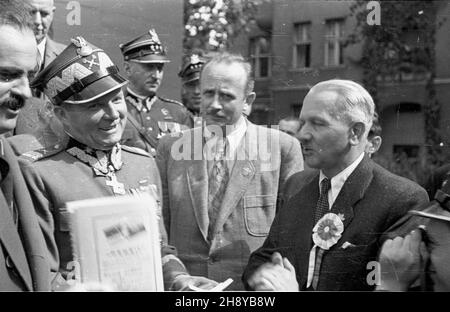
xmin=11 ymin=138 xmax=185 ymax=286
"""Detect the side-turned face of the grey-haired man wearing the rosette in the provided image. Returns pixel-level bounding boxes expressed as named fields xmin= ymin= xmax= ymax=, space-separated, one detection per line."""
xmin=299 ymin=91 xmax=351 ymax=174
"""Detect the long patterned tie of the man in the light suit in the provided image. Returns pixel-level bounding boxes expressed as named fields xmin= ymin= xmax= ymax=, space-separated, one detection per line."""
xmin=208 ymin=137 xmax=228 ymax=239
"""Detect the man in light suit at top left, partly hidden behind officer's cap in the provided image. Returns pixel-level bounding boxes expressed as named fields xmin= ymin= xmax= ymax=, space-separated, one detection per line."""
xmin=14 ymin=0 xmax=67 ymax=148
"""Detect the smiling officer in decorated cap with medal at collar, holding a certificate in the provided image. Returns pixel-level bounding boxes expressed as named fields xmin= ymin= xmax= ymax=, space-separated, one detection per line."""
xmin=13 ymin=37 xmax=216 ymax=290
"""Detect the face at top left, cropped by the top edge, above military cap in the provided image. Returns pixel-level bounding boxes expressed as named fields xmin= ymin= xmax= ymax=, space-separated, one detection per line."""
xmin=28 ymin=0 xmax=55 ymax=43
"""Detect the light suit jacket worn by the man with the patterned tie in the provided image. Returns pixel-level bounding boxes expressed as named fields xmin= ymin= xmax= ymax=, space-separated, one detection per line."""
xmin=157 ymin=122 xmax=303 ymax=290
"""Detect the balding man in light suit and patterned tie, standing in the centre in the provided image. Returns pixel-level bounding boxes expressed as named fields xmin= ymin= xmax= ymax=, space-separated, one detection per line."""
xmin=157 ymin=53 xmax=303 ymax=290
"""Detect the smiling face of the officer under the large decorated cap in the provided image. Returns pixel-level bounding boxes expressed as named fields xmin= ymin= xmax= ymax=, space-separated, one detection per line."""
xmin=55 ymin=89 xmax=127 ymax=150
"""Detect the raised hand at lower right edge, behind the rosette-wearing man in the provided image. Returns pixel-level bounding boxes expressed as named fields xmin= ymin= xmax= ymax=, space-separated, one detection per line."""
xmin=377 ymin=229 xmax=427 ymax=291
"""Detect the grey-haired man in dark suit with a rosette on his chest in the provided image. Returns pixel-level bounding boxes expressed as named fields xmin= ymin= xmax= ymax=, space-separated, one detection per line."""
xmin=243 ymin=80 xmax=428 ymax=290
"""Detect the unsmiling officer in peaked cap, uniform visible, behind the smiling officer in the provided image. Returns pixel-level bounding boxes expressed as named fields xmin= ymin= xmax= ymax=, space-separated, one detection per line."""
xmin=120 ymin=29 xmax=190 ymax=154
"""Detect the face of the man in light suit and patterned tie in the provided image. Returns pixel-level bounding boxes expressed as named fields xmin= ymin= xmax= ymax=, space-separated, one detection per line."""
xmin=200 ymin=63 xmax=255 ymax=127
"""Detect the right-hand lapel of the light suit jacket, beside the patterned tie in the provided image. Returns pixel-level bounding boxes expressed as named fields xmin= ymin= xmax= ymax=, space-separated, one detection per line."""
xmin=213 ymin=123 xmax=259 ymax=233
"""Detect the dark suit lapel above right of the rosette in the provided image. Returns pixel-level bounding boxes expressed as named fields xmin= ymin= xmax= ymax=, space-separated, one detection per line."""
xmin=331 ymin=156 xmax=373 ymax=231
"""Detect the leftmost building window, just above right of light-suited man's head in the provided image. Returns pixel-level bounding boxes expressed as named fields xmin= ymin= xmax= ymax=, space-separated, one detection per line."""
xmin=250 ymin=37 xmax=271 ymax=78
